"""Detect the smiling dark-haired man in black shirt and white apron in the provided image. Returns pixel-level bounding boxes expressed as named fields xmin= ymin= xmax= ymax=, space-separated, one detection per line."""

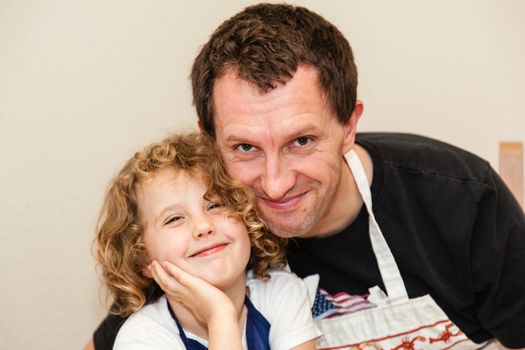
xmin=88 ymin=4 xmax=525 ymax=350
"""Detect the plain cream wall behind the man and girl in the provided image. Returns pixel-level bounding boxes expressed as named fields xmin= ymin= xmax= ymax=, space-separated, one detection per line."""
xmin=0 ymin=0 xmax=525 ymax=349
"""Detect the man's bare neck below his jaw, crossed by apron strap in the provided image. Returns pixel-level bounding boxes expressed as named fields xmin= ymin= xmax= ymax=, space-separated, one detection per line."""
xmin=311 ymin=144 xmax=373 ymax=238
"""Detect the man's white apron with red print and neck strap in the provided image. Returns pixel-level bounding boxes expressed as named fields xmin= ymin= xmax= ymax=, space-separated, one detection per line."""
xmin=317 ymin=150 xmax=497 ymax=350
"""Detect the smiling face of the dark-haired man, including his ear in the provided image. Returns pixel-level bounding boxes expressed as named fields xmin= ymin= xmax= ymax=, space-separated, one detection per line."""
xmin=213 ymin=66 xmax=357 ymax=237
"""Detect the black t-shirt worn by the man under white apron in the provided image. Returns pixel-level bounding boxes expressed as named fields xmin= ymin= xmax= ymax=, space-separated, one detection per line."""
xmin=94 ymin=133 xmax=525 ymax=350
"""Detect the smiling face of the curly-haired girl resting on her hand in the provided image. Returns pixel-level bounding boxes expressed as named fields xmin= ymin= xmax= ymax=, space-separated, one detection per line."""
xmin=136 ymin=168 xmax=250 ymax=290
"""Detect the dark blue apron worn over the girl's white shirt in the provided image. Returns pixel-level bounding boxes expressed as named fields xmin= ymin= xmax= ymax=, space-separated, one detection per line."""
xmin=166 ymin=297 xmax=270 ymax=350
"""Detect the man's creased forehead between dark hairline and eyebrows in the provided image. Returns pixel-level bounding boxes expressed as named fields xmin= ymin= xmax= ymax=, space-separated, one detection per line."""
xmin=210 ymin=67 xmax=335 ymax=143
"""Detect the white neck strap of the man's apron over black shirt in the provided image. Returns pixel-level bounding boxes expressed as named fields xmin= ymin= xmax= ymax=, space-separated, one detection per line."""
xmin=346 ymin=149 xmax=408 ymax=304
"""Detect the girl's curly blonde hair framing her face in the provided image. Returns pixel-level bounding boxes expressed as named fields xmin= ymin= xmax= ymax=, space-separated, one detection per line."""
xmin=94 ymin=133 xmax=286 ymax=316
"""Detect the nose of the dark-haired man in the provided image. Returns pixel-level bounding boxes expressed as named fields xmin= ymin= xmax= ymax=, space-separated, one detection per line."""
xmin=261 ymin=154 xmax=295 ymax=200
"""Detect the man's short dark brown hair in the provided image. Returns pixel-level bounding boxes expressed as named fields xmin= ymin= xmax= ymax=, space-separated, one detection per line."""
xmin=191 ymin=3 xmax=357 ymax=137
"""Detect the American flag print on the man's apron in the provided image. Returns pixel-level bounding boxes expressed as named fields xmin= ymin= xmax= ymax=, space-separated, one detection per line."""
xmin=312 ymin=288 xmax=376 ymax=320
